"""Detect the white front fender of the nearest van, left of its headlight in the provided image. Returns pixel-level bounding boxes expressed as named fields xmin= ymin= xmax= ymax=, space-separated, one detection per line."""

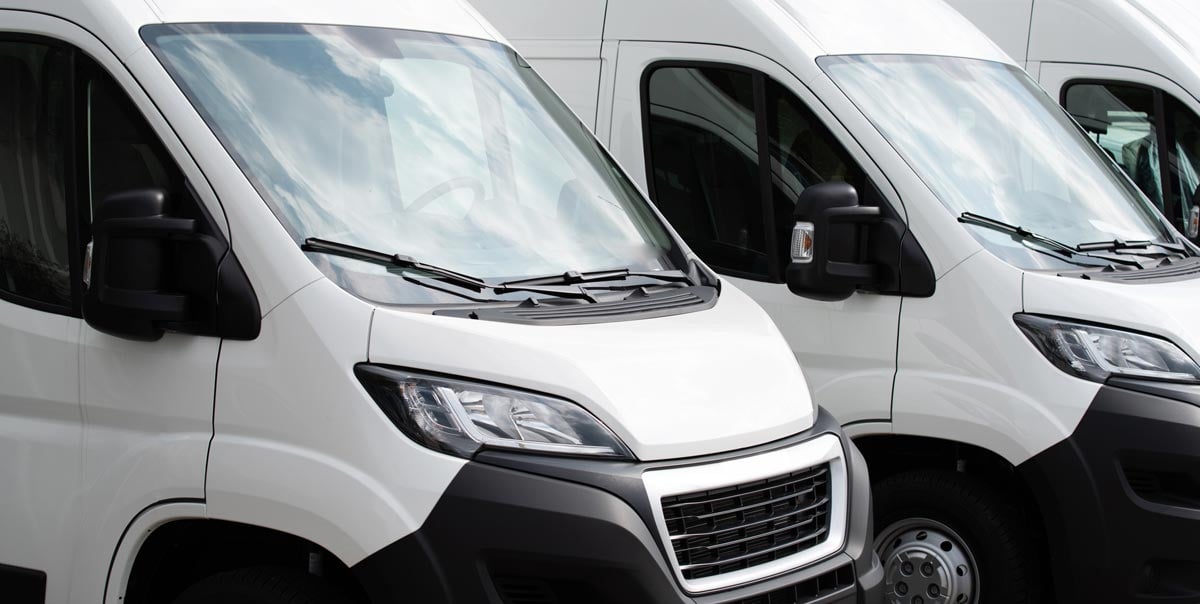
xmin=206 ymin=279 xmax=466 ymax=572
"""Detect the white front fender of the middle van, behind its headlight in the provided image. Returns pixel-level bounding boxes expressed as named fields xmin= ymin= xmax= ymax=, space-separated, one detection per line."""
xmin=893 ymin=252 xmax=1100 ymax=466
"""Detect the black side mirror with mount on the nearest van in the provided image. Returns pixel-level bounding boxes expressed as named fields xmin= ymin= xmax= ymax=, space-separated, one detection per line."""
xmin=83 ymin=189 xmax=260 ymax=341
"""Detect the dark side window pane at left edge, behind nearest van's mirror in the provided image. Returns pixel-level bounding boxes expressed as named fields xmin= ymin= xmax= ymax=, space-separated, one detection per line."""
xmin=0 ymin=41 xmax=72 ymax=309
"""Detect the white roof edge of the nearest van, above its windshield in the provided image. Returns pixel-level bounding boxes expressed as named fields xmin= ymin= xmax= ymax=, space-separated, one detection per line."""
xmin=0 ymin=0 xmax=500 ymax=55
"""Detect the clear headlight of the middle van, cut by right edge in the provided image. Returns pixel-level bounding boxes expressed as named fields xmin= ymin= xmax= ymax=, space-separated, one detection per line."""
xmin=1014 ymin=315 xmax=1200 ymax=384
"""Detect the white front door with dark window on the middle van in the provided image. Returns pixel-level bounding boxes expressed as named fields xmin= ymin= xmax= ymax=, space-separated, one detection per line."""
xmin=606 ymin=41 xmax=900 ymax=424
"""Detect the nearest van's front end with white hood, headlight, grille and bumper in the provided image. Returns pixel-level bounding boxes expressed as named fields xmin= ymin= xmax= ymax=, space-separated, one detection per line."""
xmin=338 ymin=287 xmax=882 ymax=604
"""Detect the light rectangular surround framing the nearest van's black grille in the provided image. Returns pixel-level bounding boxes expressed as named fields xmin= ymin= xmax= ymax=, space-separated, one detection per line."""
xmin=642 ymin=435 xmax=850 ymax=593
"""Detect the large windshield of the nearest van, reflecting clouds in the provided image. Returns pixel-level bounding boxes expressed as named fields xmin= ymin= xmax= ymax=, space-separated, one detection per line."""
xmin=143 ymin=24 xmax=684 ymax=304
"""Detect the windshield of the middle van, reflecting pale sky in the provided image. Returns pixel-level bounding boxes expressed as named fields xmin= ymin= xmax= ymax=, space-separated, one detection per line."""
xmin=821 ymin=55 xmax=1175 ymax=269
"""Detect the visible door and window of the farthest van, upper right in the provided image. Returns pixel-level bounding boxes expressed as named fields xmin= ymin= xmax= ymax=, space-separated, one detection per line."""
xmin=1040 ymin=62 xmax=1200 ymax=241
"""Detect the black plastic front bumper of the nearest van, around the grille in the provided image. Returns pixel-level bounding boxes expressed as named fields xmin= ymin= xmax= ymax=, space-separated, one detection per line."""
xmin=354 ymin=412 xmax=882 ymax=604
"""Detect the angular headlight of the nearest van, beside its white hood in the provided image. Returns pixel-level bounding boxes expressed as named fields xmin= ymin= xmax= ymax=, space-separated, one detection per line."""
xmin=354 ymin=364 xmax=632 ymax=459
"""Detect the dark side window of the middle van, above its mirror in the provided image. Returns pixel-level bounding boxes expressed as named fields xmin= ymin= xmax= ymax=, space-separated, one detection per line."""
xmin=644 ymin=66 xmax=875 ymax=281
